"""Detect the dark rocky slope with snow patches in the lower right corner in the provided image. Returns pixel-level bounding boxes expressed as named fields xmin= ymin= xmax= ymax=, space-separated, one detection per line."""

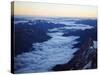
xmin=52 ymin=38 xmax=97 ymax=71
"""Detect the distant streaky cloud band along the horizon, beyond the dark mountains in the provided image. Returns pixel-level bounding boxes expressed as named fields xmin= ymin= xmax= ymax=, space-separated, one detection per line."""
xmin=14 ymin=17 xmax=93 ymax=31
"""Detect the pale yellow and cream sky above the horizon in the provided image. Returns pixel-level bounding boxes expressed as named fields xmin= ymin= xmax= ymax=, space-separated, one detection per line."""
xmin=12 ymin=1 xmax=97 ymax=18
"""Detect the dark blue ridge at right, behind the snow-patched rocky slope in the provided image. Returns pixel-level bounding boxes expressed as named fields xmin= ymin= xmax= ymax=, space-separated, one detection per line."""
xmin=63 ymin=27 xmax=97 ymax=47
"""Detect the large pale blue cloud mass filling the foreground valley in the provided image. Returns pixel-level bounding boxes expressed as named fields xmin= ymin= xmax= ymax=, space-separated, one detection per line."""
xmin=14 ymin=32 xmax=79 ymax=73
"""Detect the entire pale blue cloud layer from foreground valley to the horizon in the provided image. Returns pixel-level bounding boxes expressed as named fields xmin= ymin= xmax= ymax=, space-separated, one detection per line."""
xmin=14 ymin=17 xmax=97 ymax=73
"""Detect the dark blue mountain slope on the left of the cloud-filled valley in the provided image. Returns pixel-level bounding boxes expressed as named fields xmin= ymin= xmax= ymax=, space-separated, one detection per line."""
xmin=14 ymin=18 xmax=64 ymax=56
